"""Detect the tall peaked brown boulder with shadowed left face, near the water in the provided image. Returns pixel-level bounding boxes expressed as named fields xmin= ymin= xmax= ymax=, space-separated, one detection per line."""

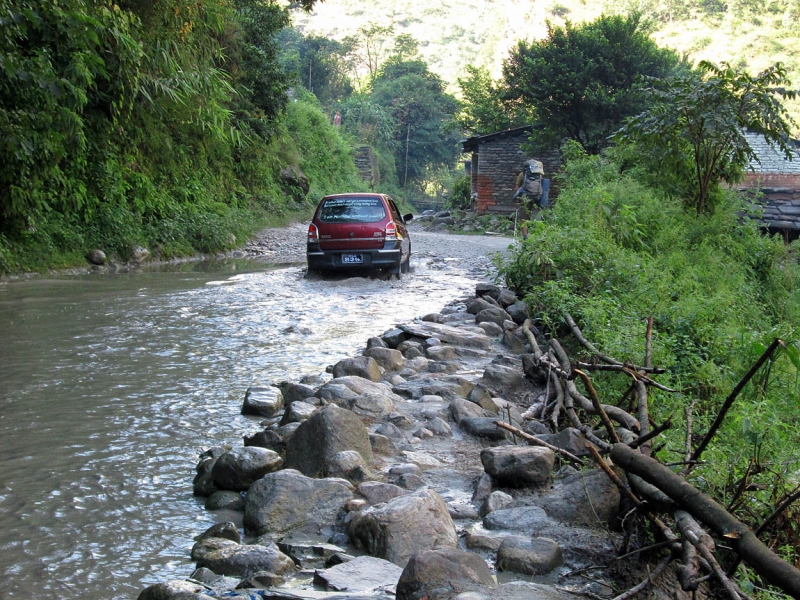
xmin=286 ymin=404 xmax=373 ymax=477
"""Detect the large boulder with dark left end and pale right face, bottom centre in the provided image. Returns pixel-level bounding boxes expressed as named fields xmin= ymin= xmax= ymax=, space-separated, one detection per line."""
xmin=347 ymin=489 xmax=458 ymax=566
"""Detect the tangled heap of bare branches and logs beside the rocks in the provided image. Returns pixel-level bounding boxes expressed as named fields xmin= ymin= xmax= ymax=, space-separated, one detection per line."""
xmin=496 ymin=315 xmax=800 ymax=600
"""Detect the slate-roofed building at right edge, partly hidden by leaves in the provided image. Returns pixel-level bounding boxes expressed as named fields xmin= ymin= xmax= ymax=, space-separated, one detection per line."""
xmin=735 ymin=134 xmax=800 ymax=241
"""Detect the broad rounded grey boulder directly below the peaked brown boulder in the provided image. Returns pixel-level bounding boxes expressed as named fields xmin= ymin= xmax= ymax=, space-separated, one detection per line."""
xmin=244 ymin=469 xmax=353 ymax=535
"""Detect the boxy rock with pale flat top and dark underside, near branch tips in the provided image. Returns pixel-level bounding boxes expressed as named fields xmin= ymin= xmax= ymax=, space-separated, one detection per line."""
xmin=481 ymin=446 xmax=555 ymax=487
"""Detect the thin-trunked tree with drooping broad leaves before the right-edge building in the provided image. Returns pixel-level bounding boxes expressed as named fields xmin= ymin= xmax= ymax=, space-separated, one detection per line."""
xmin=615 ymin=61 xmax=797 ymax=215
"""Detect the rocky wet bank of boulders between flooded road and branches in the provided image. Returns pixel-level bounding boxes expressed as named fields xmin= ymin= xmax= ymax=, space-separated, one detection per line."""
xmin=140 ymin=284 xmax=688 ymax=600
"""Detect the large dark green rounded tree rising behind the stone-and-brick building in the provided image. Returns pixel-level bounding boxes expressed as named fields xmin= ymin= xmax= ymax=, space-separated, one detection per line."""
xmin=503 ymin=13 xmax=679 ymax=152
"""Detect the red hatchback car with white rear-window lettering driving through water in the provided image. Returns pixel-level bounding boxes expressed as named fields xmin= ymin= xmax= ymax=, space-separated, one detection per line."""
xmin=306 ymin=194 xmax=413 ymax=275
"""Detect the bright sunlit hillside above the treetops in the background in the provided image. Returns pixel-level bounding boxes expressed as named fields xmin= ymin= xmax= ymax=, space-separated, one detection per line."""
xmin=294 ymin=0 xmax=800 ymax=133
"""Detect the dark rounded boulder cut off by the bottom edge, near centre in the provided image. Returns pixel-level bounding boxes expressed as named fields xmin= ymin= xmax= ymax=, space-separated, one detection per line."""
xmin=397 ymin=548 xmax=494 ymax=600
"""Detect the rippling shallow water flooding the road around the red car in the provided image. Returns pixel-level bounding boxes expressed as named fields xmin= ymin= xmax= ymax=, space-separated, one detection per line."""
xmin=0 ymin=235 xmax=504 ymax=599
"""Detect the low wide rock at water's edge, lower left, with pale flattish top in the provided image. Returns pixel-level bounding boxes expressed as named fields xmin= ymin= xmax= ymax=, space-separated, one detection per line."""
xmin=197 ymin=542 xmax=295 ymax=577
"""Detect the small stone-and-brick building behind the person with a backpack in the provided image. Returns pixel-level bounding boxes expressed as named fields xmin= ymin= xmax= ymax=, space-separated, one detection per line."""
xmin=461 ymin=125 xmax=561 ymax=214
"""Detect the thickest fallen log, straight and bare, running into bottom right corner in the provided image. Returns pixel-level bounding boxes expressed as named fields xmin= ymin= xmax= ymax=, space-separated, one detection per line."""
xmin=611 ymin=444 xmax=800 ymax=598
